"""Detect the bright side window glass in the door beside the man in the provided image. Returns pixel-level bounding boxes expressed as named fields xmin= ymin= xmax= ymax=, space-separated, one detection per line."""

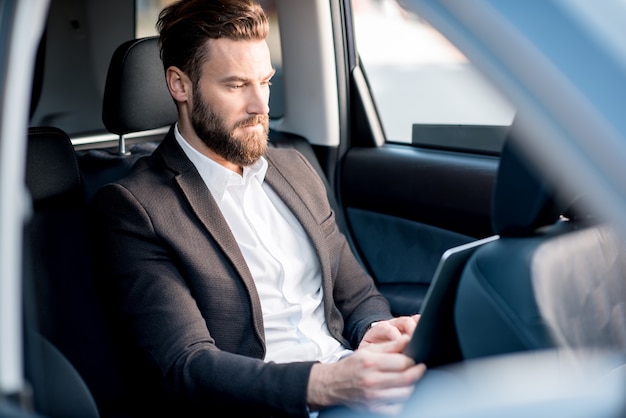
xmin=352 ymin=0 xmax=514 ymax=143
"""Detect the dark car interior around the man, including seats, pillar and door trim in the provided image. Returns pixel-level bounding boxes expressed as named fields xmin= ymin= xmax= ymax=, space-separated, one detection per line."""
xmin=8 ymin=0 xmax=626 ymax=418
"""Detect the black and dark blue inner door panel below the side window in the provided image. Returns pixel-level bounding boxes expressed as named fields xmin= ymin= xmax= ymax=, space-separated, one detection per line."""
xmin=340 ymin=144 xmax=498 ymax=314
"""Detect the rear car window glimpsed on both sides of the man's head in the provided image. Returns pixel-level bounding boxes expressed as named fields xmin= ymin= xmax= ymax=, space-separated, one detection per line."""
xmin=135 ymin=0 xmax=284 ymax=119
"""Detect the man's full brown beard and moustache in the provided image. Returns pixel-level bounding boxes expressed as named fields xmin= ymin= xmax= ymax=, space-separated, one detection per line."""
xmin=191 ymin=86 xmax=269 ymax=167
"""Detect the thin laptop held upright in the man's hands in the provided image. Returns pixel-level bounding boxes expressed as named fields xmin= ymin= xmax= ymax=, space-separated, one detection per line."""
xmin=405 ymin=235 xmax=498 ymax=367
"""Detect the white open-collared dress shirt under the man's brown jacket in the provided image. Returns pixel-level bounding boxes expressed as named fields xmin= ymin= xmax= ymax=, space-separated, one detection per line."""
xmin=175 ymin=125 xmax=351 ymax=363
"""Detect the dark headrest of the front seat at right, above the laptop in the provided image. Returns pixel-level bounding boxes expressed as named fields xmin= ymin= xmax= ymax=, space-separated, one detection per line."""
xmin=492 ymin=126 xmax=565 ymax=236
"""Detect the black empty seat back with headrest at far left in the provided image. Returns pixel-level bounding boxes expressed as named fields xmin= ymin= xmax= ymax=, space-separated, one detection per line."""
xmin=25 ymin=127 xmax=128 ymax=417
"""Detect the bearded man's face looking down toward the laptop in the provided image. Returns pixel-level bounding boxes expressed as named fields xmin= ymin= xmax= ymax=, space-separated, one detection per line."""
xmin=191 ymin=39 xmax=274 ymax=166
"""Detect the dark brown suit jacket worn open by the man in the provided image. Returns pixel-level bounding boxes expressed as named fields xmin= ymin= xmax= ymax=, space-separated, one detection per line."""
xmin=94 ymin=126 xmax=391 ymax=416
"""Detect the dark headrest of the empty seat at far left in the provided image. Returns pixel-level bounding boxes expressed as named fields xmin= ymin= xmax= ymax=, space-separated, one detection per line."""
xmin=26 ymin=127 xmax=81 ymax=206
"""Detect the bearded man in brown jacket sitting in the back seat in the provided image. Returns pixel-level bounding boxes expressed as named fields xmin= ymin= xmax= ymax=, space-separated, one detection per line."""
xmin=94 ymin=0 xmax=425 ymax=417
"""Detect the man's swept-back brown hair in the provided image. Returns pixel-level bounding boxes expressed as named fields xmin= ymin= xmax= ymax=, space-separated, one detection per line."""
xmin=156 ymin=0 xmax=269 ymax=84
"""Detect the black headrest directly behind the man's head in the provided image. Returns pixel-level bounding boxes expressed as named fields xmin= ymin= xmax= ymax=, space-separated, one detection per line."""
xmin=102 ymin=36 xmax=178 ymax=135
